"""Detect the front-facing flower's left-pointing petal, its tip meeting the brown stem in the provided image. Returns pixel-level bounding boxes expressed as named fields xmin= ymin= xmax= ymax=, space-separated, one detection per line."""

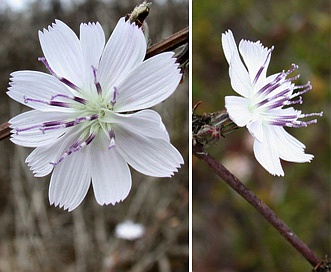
xmin=9 ymin=110 xmax=70 ymax=147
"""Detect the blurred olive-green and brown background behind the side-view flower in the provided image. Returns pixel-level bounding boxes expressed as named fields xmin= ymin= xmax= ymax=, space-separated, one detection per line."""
xmin=192 ymin=0 xmax=330 ymax=272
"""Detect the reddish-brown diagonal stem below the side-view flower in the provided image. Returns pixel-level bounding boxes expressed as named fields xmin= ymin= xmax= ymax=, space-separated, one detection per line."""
xmin=193 ymin=144 xmax=321 ymax=267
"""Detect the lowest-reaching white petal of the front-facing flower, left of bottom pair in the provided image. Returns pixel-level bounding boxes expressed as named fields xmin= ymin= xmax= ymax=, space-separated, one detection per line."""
xmin=49 ymin=143 xmax=91 ymax=212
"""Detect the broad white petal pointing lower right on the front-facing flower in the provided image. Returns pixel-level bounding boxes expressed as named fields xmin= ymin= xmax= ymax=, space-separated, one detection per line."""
xmin=114 ymin=125 xmax=184 ymax=177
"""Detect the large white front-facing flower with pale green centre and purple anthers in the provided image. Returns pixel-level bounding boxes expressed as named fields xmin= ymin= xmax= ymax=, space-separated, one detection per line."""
xmin=7 ymin=18 xmax=183 ymax=211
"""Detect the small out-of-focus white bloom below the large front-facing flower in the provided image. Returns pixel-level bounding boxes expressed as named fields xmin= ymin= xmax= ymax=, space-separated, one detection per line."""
xmin=115 ymin=220 xmax=145 ymax=240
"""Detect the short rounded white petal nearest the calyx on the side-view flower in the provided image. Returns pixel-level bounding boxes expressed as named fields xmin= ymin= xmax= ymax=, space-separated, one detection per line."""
xmin=225 ymin=96 xmax=252 ymax=127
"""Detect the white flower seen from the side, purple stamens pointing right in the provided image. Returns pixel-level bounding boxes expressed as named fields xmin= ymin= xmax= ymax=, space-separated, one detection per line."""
xmin=222 ymin=30 xmax=322 ymax=176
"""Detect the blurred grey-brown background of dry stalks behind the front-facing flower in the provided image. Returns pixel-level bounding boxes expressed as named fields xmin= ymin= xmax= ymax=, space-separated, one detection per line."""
xmin=0 ymin=0 xmax=189 ymax=272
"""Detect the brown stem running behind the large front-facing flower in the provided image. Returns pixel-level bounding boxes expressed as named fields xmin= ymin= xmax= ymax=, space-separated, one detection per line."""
xmin=0 ymin=28 xmax=189 ymax=141
